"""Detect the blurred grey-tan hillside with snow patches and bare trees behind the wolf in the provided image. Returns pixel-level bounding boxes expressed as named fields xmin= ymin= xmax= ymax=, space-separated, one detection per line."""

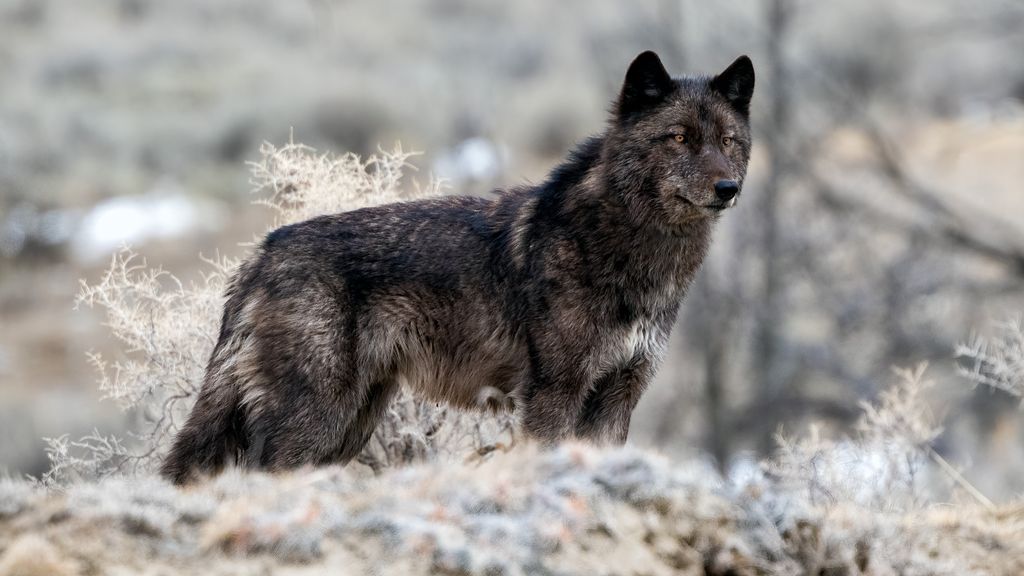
xmin=0 ymin=0 xmax=1024 ymax=496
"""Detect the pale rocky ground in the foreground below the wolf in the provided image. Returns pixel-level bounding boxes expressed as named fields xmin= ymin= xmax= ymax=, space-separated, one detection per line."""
xmin=0 ymin=446 xmax=1024 ymax=576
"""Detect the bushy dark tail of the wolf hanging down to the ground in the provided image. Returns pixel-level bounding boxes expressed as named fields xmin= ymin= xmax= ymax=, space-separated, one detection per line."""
xmin=160 ymin=338 xmax=245 ymax=485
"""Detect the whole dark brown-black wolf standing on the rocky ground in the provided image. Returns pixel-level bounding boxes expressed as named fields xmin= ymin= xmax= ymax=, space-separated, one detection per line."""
xmin=162 ymin=51 xmax=754 ymax=484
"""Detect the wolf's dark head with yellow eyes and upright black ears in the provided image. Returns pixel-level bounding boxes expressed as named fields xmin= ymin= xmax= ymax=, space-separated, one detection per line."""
xmin=604 ymin=51 xmax=754 ymax=231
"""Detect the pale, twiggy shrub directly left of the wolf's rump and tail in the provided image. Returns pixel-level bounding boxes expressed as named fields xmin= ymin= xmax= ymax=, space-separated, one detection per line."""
xmin=72 ymin=248 xmax=237 ymax=475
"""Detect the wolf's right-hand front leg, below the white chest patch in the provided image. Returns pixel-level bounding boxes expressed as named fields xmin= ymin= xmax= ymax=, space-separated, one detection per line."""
xmin=574 ymin=356 xmax=654 ymax=444
